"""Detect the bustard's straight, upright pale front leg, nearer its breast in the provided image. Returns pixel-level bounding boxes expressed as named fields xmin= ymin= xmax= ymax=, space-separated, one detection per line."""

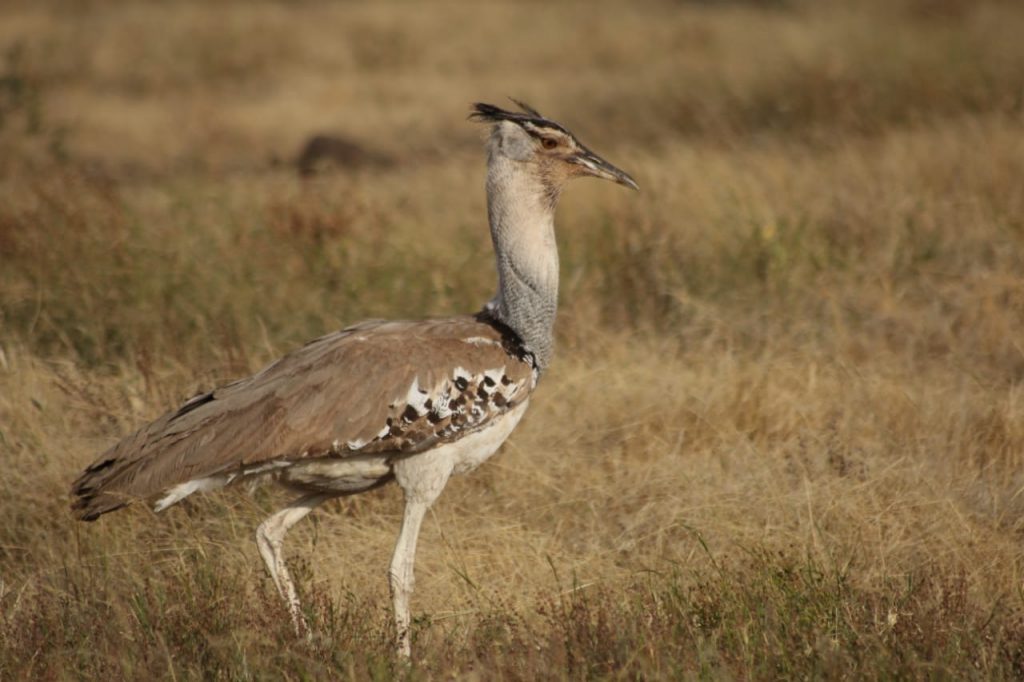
xmin=388 ymin=453 xmax=453 ymax=658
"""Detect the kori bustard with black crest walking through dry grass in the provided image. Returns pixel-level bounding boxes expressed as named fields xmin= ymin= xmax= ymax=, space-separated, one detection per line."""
xmin=72 ymin=102 xmax=638 ymax=656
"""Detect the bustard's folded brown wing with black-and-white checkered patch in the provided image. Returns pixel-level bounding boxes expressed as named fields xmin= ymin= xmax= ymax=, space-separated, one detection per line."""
xmin=72 ymin=313 xmax=537 ymax=518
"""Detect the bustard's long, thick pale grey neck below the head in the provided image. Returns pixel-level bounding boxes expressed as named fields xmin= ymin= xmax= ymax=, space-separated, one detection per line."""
xmin=487 ymin=152 xmax=558 ymax=371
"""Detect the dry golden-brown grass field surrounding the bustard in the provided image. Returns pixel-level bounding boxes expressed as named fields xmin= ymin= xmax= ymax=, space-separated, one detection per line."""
xmin=0 ymin=0 xmax=1024 ymax=680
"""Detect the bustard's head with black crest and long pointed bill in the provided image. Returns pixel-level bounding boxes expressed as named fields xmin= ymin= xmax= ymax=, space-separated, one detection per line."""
xmin=470 ymin=99 xmax=640 ymax=197
